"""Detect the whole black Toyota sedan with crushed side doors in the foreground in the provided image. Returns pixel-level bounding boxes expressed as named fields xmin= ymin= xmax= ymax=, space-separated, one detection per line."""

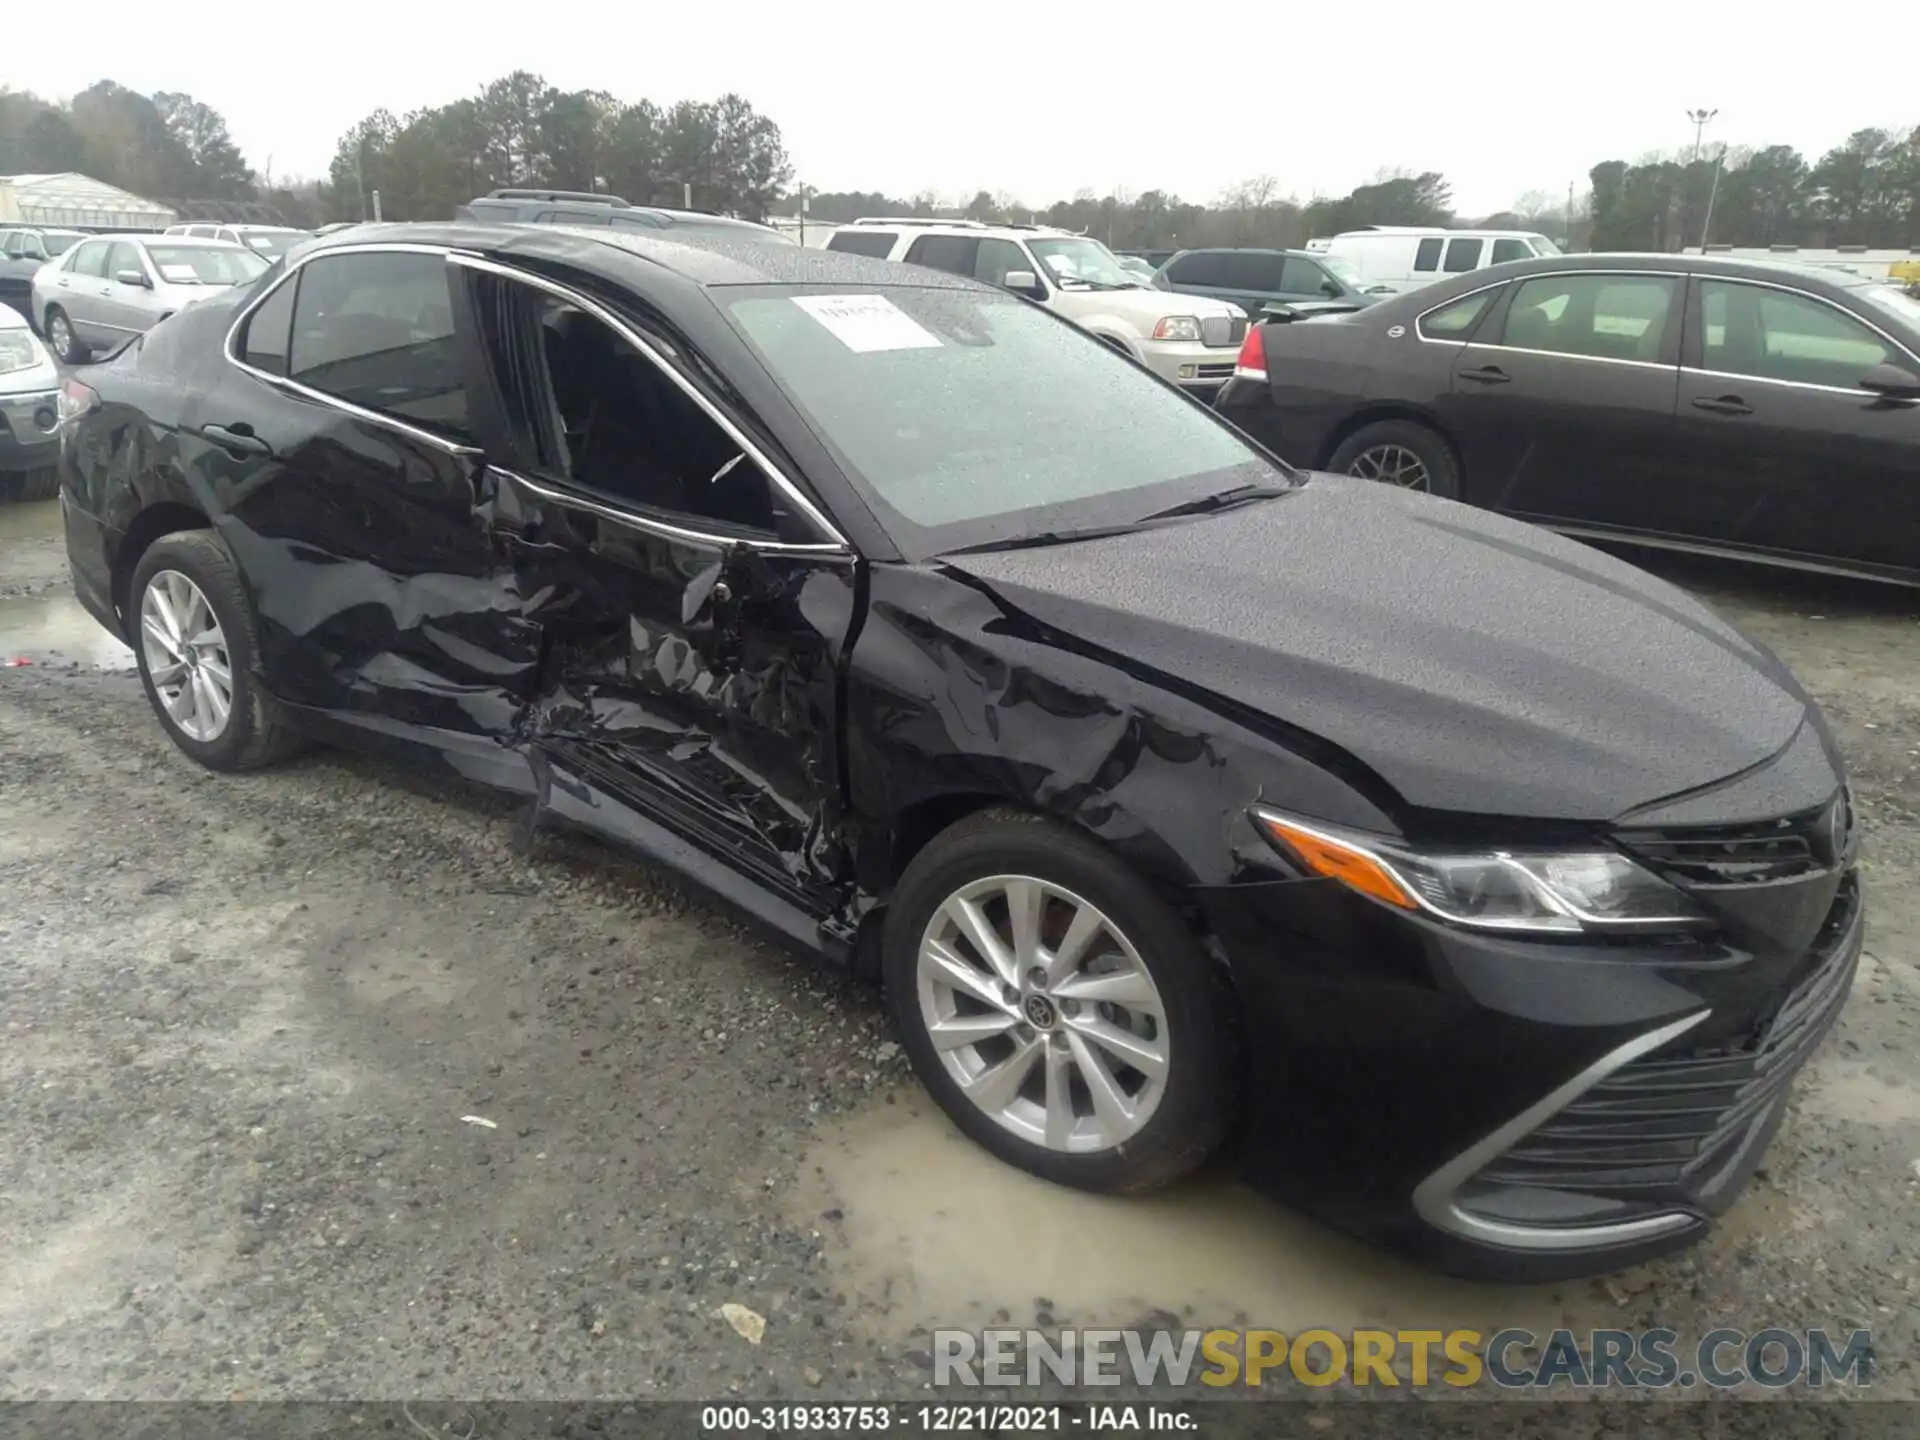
xmin=61 ymin=225 xmax=1862 ymax=1277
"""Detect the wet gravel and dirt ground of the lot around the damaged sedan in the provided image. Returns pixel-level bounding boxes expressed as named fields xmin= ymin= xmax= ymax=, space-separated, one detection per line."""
xmin=0 ymin=505 xmax=1920 ymax=1400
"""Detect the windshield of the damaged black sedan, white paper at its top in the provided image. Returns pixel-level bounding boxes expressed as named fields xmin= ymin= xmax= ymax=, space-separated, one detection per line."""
xmin=728 ymin=288 xmax=1290 ymax=557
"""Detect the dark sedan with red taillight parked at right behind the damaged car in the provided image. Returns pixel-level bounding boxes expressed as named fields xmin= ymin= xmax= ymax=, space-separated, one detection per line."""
xmin=1219 ymin=255 xmax=1920 ymax=584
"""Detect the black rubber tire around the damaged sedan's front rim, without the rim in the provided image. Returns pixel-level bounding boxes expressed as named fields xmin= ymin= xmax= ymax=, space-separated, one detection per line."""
xmin=881 ymin=808 xmax=1236 ymax=1194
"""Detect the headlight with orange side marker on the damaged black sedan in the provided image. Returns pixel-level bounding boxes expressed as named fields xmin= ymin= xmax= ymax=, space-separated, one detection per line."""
xmin=1254 ymin=808 xmax=1707 ymax=935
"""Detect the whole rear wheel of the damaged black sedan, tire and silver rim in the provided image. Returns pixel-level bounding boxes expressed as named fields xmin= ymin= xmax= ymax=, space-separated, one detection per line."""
xmin=127 ymin=530 xmax=301 ymax=770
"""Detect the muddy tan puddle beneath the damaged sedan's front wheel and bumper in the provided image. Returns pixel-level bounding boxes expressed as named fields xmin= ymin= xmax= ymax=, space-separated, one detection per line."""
xmin=795 ymin=1087 xmax=1611 ymax=1336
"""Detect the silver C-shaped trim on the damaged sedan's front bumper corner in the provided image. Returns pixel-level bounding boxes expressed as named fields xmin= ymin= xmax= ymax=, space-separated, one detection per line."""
xmin=1413 ymin=1010 xmax=1713 ymax=1252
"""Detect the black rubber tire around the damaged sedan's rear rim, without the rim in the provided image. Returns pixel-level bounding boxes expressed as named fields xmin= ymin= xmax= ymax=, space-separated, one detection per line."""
xmin=127 ymin=530 xmax=305 ymax=770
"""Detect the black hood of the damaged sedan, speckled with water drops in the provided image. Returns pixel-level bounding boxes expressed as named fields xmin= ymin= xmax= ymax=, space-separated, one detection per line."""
xmin=948 ymin=476 xmax=1837 ymax=820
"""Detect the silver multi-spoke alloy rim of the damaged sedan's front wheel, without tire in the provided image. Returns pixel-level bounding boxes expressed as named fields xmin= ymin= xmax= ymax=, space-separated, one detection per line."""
xmin=916 ymin=876 xmax=1173 ymax=1154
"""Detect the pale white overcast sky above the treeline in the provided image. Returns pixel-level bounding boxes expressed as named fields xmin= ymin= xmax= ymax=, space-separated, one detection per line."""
xmin=33 ymin=0 xmax=1920 ymax=215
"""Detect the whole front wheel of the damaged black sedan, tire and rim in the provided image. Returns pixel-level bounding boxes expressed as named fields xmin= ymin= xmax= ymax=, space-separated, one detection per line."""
xmin=881 ymin=810 xmax=1233 ymax=1194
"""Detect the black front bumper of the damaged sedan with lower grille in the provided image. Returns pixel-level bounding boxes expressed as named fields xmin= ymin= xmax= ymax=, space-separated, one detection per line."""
xmin=1198 ymin=817 xmax=1864 ymax=1281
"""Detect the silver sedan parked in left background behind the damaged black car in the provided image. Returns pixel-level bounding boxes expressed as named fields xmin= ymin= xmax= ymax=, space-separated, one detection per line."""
xmin=33 ymin=234 xmax=269 ymax=365
